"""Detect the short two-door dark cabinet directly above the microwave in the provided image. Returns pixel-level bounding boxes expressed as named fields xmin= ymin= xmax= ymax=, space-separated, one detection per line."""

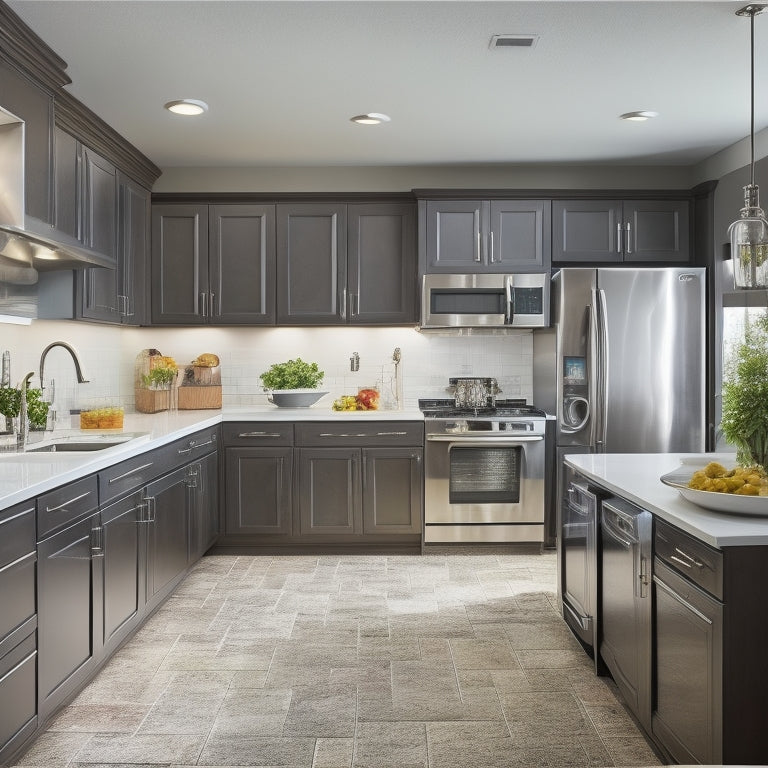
xmin=419 ymin=199 xmax=551 ymax=273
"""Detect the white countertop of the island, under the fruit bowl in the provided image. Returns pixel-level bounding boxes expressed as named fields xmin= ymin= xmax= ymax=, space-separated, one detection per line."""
xmin=565 ymin=453 xmax=768 ymax=549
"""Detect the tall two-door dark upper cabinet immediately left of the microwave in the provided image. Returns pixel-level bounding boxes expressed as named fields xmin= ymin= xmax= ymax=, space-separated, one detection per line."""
xmin=277 ymin=202 xmax=416 ymax=325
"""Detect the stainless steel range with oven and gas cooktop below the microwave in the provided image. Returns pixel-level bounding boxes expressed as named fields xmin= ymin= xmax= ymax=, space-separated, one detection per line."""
xmin=419 ymin=399 xmax=546 ymax=544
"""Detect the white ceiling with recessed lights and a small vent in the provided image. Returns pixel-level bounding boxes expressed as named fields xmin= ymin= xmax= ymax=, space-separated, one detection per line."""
xmin=6 ymin=0 xmax=768 ymax=168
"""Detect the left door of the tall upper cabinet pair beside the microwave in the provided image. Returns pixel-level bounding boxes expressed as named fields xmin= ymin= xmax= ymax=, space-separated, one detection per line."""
xmin=277 ymin=203 xmax=349 ymax=325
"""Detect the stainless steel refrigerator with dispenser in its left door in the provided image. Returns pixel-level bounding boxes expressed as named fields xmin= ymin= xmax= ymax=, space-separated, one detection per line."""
xmin=552 ymin=267 xmax=706 ymax=465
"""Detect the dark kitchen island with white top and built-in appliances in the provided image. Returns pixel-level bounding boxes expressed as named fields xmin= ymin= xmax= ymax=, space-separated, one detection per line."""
xmin=558 ymin=454 xmax=768 ymax=765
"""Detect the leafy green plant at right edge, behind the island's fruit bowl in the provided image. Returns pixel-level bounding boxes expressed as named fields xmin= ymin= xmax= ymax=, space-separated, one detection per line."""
xmin=720 ymin=312 xmax=768 ymax=469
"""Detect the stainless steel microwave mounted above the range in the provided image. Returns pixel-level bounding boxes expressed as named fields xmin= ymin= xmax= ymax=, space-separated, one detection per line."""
xmin=421 ymin=272 xmax=550 ymax=329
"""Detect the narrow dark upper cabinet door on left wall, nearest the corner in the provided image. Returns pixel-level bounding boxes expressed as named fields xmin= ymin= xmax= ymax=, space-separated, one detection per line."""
xmin=117 ymin=173 xmax=151 ymax=325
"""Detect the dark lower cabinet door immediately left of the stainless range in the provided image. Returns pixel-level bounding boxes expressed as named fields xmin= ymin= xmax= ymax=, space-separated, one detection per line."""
xmin=363 ymin=448 xmax=423 ymax=534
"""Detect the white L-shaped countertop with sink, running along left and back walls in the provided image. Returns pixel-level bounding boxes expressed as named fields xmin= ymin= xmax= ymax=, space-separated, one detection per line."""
xmin=0 ymin=405 xmax=424 ymax=509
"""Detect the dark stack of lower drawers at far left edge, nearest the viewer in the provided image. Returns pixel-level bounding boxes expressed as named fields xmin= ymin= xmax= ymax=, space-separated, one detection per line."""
xmin=0 ymin=502 xmax=37 ymax=764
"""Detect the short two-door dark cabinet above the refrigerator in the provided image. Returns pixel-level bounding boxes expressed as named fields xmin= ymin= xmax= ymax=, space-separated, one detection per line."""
xmin=552 ymin=200 xmax=690 ymax=263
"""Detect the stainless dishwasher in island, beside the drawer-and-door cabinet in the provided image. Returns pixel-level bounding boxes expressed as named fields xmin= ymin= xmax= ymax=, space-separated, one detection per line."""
xmin=599 ymin=498 xmax=653 ymax=731
